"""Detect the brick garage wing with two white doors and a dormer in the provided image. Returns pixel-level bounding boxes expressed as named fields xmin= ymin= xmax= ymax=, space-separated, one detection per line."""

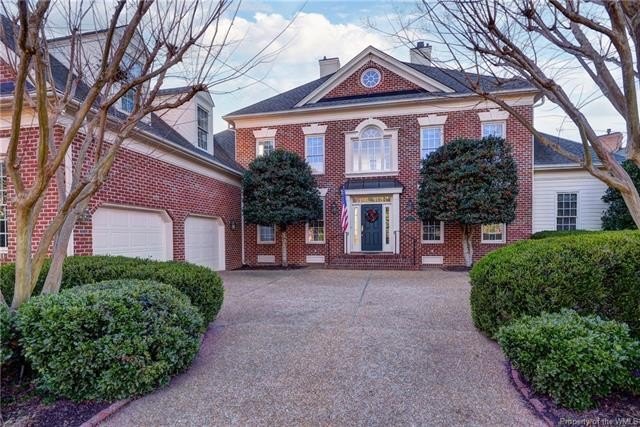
xmin=0 ymin=16 xmax=242 ymax=270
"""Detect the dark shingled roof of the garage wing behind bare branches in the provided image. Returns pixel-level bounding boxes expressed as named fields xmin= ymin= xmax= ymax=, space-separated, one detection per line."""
xmin=0 ymin=14 xmax=242 ymax=174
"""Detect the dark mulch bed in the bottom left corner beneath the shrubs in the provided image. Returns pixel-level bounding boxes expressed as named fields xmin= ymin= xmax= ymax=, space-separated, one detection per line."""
xmin=0 ymin=368 xmax=110 ymax=427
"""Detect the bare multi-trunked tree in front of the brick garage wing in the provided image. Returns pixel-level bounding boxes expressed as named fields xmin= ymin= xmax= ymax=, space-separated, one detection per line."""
xmin=0 ymin=0 xmax=284 ymax=309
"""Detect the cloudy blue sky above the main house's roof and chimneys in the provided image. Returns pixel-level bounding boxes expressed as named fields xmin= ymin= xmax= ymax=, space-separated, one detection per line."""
xmin=214 ymin=0 xmax=624 ymax=145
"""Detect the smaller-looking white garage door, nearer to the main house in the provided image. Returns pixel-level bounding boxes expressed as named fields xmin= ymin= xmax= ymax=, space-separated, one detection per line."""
xmin=184 ymin=216 xmax=225 ymax=270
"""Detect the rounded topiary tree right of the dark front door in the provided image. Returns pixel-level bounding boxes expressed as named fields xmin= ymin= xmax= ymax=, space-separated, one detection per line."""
xmin=418 ymin=137 xmax=518 ymax=267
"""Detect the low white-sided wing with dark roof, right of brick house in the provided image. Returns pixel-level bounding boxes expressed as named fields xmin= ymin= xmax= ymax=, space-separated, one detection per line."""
xmin=533 ymin=132 xmax=625 ymax=232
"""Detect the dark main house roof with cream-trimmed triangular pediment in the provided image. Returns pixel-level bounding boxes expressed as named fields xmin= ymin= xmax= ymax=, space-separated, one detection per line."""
xmin=224 ymin=46 xmax=536 ymax=119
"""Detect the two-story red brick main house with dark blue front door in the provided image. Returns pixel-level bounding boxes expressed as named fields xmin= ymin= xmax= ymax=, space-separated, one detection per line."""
xmin=224 ymin=44 xmax=539 ymax=268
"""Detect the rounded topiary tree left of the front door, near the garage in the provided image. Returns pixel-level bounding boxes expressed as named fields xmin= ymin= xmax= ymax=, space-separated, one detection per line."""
xmin=242 ymin=150 xmax=322 ymax=267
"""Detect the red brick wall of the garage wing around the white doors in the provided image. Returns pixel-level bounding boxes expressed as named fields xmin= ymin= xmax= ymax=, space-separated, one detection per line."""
xmin=0 ymin=124 xmax=242 ymax=269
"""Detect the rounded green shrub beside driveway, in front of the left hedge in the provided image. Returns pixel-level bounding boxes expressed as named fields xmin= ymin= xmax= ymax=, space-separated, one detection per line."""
xmin=17 ymin=280 xmax=202 ymax=400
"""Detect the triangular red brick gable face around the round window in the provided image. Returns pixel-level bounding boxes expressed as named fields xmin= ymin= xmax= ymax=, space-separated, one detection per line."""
xmin=322 ymin=61 xmax=422 ymax=99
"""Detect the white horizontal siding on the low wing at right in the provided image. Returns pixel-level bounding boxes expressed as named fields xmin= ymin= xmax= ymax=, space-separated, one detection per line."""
xmin=533 ymin=170 xmax=607 ymax=233
